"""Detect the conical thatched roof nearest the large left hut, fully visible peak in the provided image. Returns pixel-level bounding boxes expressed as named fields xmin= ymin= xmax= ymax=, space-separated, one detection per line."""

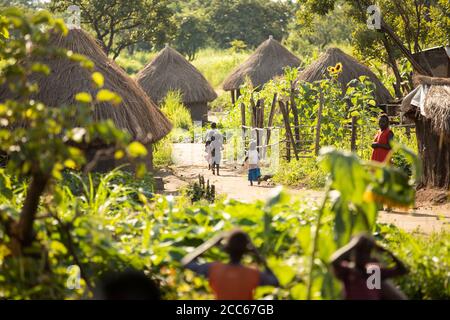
xmin=136 ymin=46 xmax=217 ymax=103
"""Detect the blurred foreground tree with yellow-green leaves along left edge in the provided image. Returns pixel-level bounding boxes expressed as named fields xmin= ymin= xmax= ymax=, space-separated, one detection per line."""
xmin=0 ymin=8 xmax=142 ymax=256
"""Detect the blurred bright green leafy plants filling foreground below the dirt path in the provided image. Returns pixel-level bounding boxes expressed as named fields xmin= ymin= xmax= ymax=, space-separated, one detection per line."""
xmin=0 ymin=142 xmax=450 ymax=299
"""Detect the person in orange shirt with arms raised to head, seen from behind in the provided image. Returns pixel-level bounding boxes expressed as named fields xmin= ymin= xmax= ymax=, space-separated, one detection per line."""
xmin=181 ymin=229 xmax=279 ymax=300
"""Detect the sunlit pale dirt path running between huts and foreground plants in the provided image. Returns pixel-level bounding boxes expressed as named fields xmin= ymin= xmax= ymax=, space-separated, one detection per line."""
xmin=158 ymin=146 xmax=450 ymax=233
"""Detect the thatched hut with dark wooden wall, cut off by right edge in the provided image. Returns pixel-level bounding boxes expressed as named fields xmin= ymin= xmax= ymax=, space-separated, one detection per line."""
xmin=401 ymin=76 xmax=450 ymax=189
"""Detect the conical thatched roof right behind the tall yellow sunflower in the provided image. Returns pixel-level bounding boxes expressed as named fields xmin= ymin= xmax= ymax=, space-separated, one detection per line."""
xmin=298 ymin=48 xmax=392 ymax=104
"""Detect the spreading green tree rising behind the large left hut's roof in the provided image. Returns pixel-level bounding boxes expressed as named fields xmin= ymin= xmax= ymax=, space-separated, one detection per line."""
xmin=50 ymin=0 xmax=175 ymax=59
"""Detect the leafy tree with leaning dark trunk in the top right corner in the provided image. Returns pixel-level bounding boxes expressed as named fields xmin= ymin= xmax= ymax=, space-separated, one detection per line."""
xmin=300 ymin=0 xmax=450 ymax=96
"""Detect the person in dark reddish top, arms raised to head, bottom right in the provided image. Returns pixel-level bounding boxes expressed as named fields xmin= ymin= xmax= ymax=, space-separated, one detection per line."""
xmin=331 ymin=234 xmax=407 ymax=300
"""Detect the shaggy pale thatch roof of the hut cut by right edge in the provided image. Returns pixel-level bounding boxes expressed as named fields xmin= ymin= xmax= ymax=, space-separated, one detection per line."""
xmin=401 ymin=76 xmax=450 ymax=138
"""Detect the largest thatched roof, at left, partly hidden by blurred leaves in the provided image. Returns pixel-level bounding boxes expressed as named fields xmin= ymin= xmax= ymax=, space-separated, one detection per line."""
xmin=0 ymin=29 xmax=172 ymax=144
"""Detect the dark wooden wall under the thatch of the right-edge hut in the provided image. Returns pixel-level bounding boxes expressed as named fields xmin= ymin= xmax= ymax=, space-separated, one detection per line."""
xmin=416 ymin=116 xmax=450 ymax=190
